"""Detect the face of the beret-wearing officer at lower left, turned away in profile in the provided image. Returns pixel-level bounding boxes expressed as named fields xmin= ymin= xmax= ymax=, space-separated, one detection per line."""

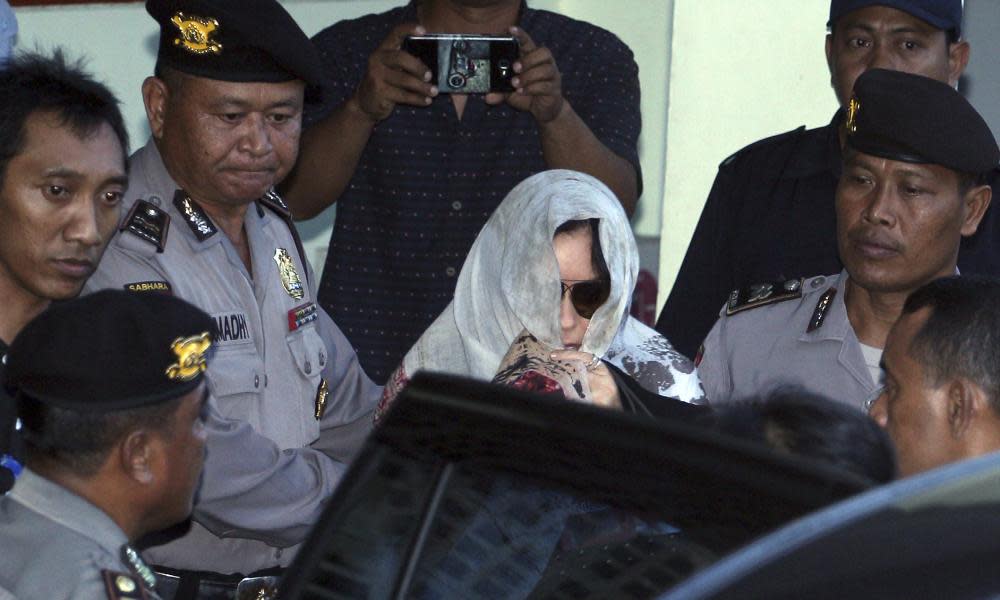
xmin=158 ymin=383 xmax=208 ymax=527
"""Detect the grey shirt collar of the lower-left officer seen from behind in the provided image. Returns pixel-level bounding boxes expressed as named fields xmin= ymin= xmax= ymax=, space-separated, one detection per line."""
xmin=9 ymin=468 xmax=128 ymax=556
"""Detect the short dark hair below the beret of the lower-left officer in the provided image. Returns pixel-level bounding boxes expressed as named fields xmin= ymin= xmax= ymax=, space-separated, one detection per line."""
xmin=17 ymin=394 xmax=184 ymax=477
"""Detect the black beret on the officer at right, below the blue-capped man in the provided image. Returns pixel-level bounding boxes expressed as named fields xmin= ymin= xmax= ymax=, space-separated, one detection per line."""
xmin=845 ymin=69 xmax=1000 ymax=174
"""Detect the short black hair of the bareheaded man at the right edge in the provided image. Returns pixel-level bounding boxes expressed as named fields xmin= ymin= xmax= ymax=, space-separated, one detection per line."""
xmin=903 ymin=275 xmax=1000 ymax=414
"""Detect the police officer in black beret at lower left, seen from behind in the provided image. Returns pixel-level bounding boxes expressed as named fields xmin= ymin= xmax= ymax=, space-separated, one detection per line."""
xmin=0 ymin=290 xmax=214 ymax=600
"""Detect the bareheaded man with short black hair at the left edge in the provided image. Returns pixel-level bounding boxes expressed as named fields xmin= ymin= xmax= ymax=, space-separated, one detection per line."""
xmin=0 ymin=53 xmax=128 ymax=493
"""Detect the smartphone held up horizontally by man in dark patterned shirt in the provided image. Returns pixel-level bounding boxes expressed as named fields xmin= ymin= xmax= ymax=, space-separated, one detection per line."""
xmin=403 ymin=33 xmax=521 ymax=94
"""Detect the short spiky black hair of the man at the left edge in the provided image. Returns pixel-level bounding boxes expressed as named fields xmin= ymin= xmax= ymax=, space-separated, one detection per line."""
xmin=0 ymin=50 xmax=128 ymax=184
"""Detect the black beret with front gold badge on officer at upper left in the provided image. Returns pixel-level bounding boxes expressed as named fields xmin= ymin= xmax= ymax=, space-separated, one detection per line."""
xmin=146 ymin=0 xmax=323 ymax=88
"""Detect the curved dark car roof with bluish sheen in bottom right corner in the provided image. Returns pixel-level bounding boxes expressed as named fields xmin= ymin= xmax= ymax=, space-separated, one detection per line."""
xmin=663 ymin=453 xmax=1000 ymax=600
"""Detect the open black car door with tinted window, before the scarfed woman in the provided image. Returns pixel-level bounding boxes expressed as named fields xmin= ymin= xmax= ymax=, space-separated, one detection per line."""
xmin=281 ymin=374 xmax=869 ymax=598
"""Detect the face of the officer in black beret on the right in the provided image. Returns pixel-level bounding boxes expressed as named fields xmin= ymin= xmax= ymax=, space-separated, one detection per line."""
xmin=836 ymin=149 xmax=982 ymax=292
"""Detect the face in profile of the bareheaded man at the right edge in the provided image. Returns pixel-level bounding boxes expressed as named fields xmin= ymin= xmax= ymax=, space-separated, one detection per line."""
xmin=871 ymin=308 xmax=961 ymax=477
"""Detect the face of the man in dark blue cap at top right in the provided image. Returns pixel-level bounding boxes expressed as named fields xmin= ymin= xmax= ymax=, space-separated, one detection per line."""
xmin=826 ymin=6 xmax=969 ymax=106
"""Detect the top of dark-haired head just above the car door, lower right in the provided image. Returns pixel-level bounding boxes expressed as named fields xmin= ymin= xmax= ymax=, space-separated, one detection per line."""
xmin=708 ymin=387 xmax=896 ymax=483
